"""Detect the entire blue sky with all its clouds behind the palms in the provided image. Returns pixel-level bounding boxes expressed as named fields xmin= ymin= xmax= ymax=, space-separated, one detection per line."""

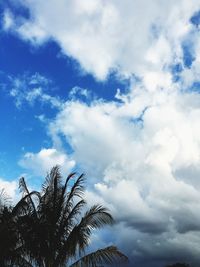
xmin=0 ymin=0 xmax=200 ymax=267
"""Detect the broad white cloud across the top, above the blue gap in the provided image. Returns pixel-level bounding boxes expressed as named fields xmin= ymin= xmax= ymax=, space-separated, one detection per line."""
xmin=4 ymin=0 xmax=200 ymax=79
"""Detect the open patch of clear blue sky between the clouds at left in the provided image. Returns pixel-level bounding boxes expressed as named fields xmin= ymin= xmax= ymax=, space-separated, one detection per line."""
xmin=0 ymin=4 xmax=129 ymax=179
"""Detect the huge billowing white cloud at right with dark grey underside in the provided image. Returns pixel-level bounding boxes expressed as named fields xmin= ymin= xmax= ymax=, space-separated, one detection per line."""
xmin=46 ymin=84 xmax=200 ymax=266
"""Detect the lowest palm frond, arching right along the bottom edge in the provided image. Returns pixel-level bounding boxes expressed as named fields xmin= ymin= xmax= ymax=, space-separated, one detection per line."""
xmin=70 ymin=246 xmax=128 ymax=267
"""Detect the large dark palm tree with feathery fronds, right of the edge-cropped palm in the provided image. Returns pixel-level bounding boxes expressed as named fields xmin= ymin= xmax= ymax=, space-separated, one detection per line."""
xmin=14 ymin=166 xmax=127 ymax=267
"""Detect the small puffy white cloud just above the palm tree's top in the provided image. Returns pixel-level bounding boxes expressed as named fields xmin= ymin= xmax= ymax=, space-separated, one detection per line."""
xmin=19 ymin=148 xmax=75 ymax=176
